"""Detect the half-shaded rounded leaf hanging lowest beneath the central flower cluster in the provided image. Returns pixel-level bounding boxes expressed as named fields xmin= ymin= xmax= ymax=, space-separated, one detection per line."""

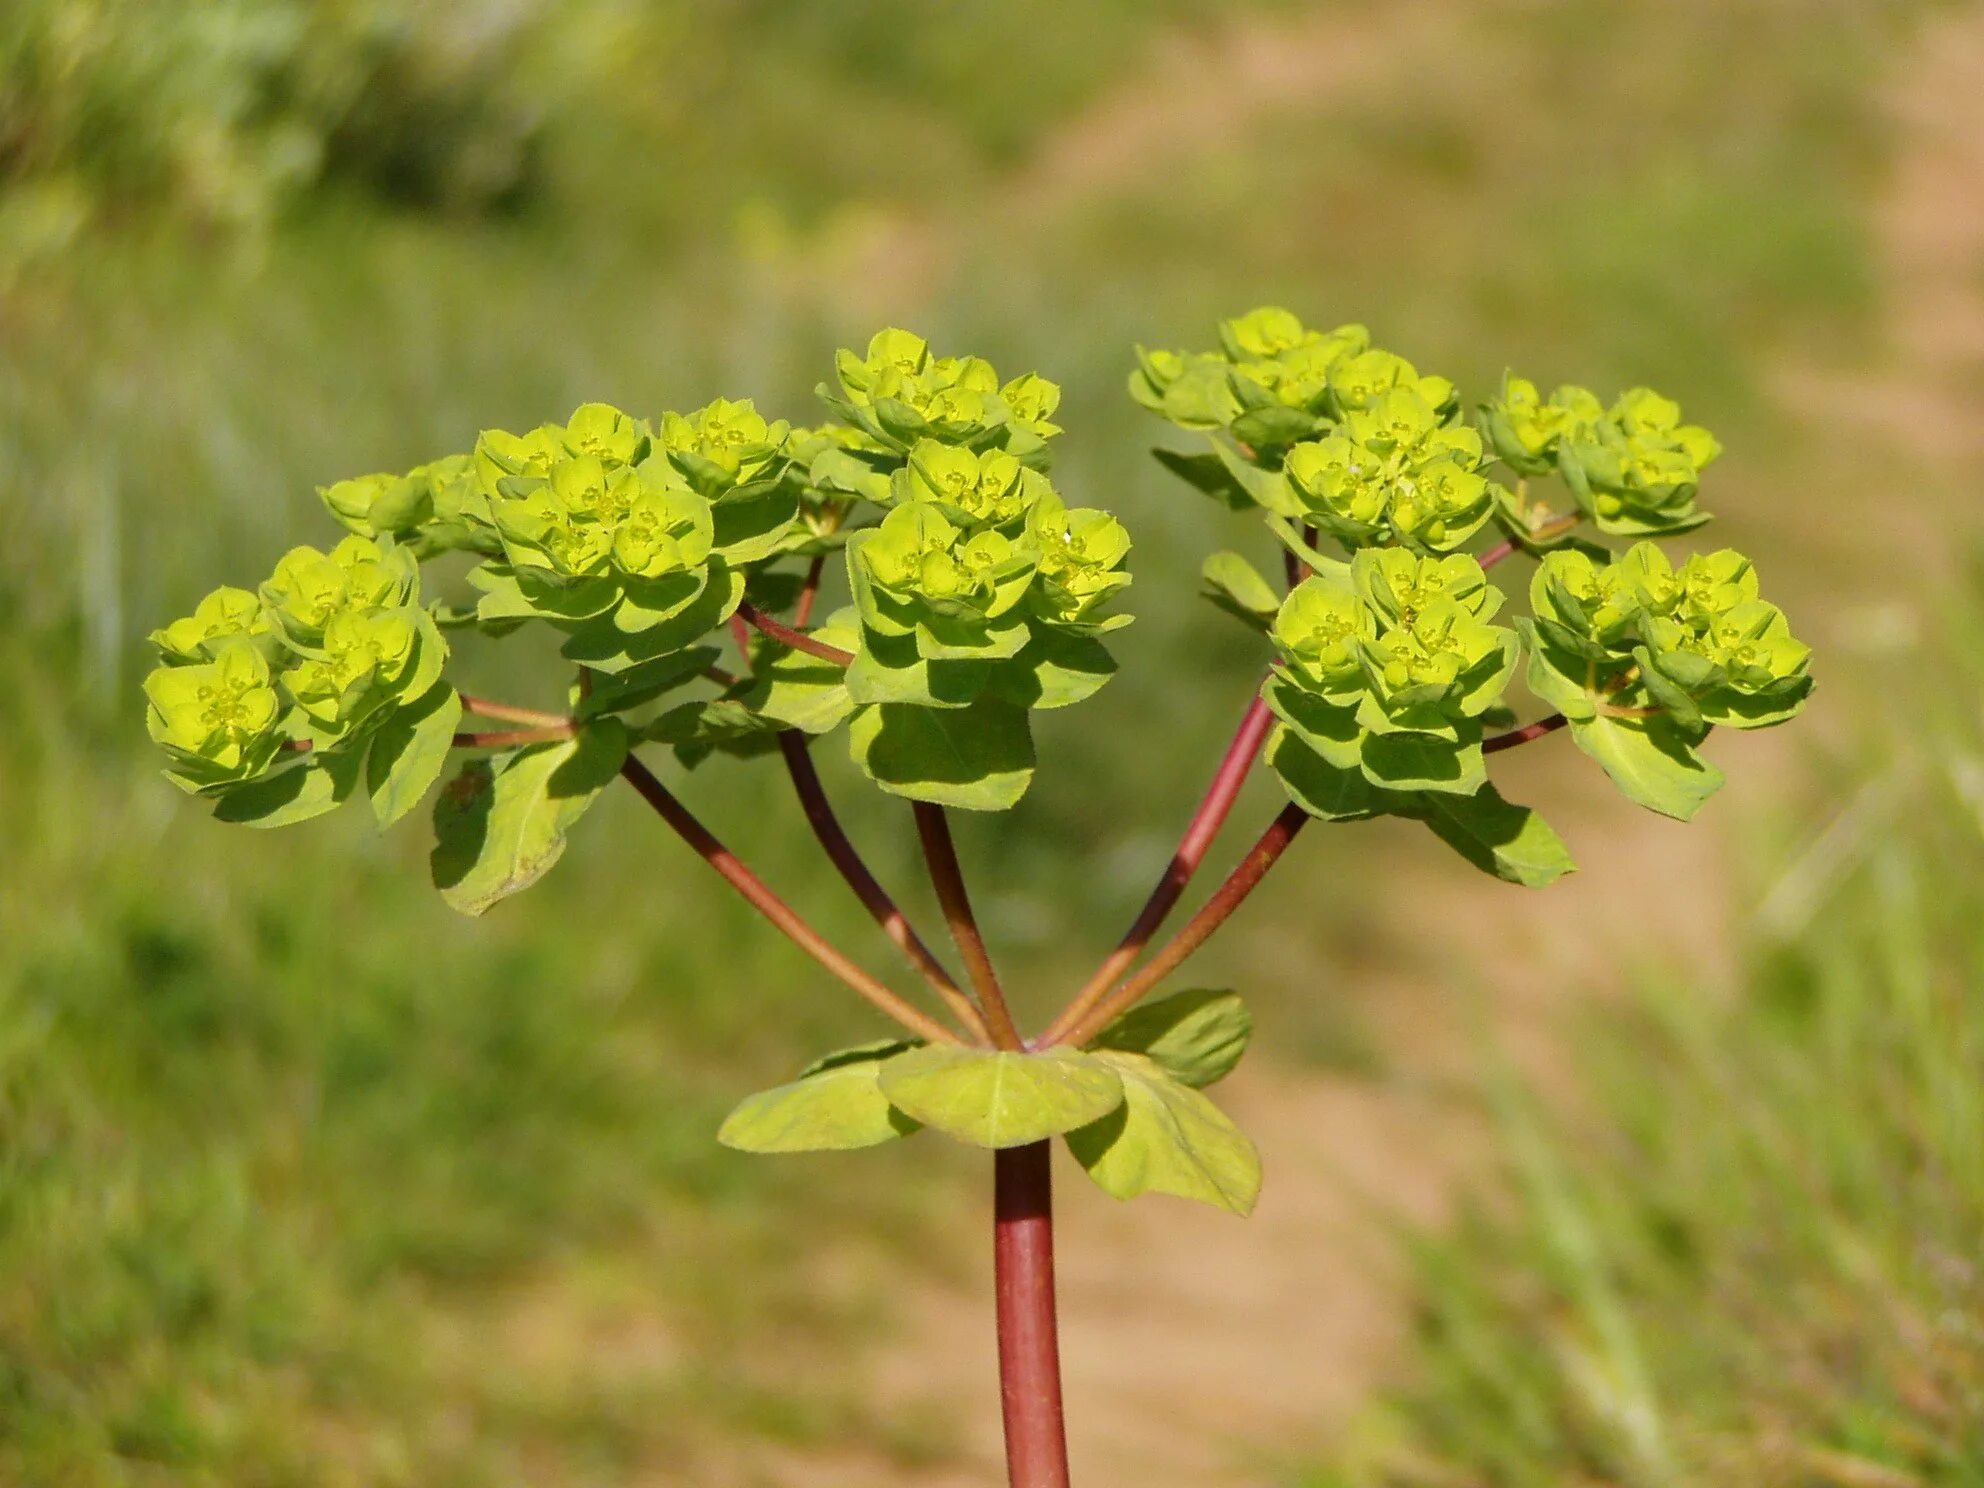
xmin=847 ymin=698 xmax=1034 ymax=811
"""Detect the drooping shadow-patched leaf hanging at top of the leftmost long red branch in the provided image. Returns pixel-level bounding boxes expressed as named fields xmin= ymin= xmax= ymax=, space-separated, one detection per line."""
xmin=429 ymin=718 xmax=627 ymax=915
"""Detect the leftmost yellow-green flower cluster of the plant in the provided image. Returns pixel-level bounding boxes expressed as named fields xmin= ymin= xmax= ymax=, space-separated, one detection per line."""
xmin=145 ymin=536 xmax=448 ymax=796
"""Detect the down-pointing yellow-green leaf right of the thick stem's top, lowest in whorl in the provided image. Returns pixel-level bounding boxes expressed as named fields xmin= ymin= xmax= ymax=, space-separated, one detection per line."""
xmin=1067 ymin=1054 xmax=1260 ymax=1218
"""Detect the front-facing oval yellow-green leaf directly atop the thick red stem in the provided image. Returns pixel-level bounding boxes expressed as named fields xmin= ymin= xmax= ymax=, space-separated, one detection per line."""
xmin=881 ymin=1046 xmax=1123 ymax=1147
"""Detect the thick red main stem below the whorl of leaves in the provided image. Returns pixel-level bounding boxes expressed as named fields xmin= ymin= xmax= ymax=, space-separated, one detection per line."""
xmin=992 ymin=1141 xmax=1067 ymax=1488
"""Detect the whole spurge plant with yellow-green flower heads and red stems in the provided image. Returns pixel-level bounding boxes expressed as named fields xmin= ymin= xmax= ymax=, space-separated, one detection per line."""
xmin=145 ymin=310 xmax=1811 ymax=1488
